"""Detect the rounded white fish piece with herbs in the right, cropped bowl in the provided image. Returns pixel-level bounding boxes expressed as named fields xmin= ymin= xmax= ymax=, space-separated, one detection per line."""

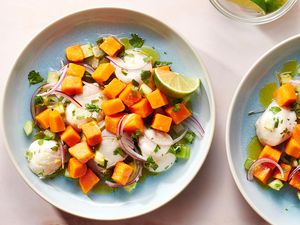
xmin=256 ymin=101 xmax=297 ymax=146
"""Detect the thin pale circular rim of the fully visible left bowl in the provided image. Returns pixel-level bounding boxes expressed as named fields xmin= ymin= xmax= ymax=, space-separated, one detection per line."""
xmin=0 ymin=7 xmax=216 ymax=221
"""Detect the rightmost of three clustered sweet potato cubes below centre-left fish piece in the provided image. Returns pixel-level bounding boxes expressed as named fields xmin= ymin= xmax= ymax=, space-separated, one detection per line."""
xmin=81 ymin=121 xmax=102 ymax=146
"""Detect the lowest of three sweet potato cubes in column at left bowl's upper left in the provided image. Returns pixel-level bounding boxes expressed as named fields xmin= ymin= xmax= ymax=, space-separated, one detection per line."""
xmin=61 ymin=76 xmax=83 ymax=95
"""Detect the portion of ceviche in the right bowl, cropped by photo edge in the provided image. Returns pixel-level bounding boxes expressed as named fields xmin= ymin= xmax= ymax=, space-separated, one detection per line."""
xmin=245 ymin=60 xmax=300 ymax=200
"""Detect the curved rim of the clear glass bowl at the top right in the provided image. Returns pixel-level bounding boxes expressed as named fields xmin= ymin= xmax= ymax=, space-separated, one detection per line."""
xmin=209 ymin=0 xmax=298 ymax=25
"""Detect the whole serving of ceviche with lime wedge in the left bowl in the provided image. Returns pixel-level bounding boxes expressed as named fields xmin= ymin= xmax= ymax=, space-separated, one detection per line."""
xmin=24 ymin=34 xmax=204 ymax=194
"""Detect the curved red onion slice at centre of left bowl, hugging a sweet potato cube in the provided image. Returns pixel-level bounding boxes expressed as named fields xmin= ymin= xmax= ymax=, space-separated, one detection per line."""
xmin=117 ymin=115 xmax=146 ymax=162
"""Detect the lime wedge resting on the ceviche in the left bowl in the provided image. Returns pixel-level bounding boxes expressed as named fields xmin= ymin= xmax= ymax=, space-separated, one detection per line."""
xmin=154 ymin=68 xmax=200 ymax=98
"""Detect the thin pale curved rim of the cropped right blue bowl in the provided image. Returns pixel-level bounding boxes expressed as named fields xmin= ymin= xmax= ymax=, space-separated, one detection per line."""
xmin=225 ymin=34 xmax=300 ymax=224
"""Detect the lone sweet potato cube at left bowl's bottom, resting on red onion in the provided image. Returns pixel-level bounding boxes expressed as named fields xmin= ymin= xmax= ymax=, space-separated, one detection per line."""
xmin=111 ymin=162 xmax=133 ymax=185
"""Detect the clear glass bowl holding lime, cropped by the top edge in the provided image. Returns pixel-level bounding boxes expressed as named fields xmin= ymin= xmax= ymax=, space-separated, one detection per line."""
xmin=210 ymin=0 xmax=297 ymax=25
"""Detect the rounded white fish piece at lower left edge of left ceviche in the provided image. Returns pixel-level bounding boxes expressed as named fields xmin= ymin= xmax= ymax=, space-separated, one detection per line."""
xmin=27 ymin=140 xmax=61 ymax=177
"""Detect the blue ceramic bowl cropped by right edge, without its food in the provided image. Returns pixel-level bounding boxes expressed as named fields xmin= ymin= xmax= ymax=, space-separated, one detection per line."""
xmin=226 ymin=33 xmax=300 ymax=225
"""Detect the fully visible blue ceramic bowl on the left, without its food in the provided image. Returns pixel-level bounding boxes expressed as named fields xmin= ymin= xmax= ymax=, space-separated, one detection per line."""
xmin=2 ymin=8 xmax=215 ymax=220
